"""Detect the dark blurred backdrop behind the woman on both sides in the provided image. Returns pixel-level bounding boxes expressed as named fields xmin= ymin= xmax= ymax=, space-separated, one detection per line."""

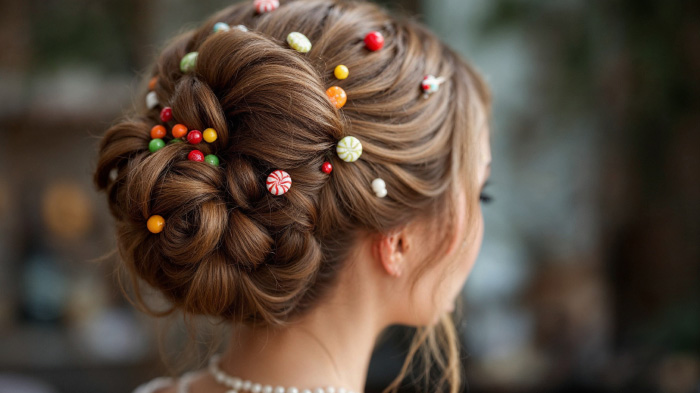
xmin=0 ymin=0 xmax=700 ymax=393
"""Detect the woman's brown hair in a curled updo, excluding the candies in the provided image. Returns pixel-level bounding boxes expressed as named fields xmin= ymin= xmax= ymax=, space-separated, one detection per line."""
xmin=94 ymin=0 xmax=490 ymax=391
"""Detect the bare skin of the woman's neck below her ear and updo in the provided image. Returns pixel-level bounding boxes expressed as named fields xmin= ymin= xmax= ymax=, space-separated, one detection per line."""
xmin=220 ymin=234 xmax=401 ymax=392
